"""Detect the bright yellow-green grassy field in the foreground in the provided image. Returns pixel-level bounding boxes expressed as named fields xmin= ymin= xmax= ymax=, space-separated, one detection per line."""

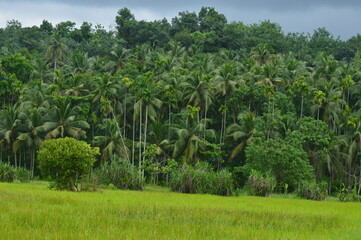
xmin=0 ymin=183 xmax=361 ymax=240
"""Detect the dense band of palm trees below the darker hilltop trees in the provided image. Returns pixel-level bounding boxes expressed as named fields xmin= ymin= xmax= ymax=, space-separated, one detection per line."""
xmin=0 ymin=37 xmax=361 ymax=189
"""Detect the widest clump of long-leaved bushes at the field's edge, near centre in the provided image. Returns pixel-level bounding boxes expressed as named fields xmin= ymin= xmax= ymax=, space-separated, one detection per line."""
xmin=170 ymin=163 xmax=234 ymax=196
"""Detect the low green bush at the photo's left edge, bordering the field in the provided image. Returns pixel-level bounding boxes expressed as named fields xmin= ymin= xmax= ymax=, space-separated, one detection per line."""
xmin=0 ymin=163 xmax=31 ymax=182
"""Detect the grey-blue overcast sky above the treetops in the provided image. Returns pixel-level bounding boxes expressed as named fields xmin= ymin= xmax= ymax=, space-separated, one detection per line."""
xmin=0 ymin=0 xmax=361 ymax=39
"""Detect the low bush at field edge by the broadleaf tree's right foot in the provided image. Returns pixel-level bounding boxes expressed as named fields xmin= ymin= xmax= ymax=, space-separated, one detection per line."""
xmin=298 ymin=182 xmax=327 ymax=201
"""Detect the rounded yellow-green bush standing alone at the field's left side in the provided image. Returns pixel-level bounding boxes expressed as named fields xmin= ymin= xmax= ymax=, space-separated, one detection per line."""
xmin=38 ymin=138 xmax=99 ymax=191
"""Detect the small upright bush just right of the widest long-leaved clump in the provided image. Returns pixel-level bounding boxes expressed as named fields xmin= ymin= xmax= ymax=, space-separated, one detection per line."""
xmin=248 ymin=170 xmax=276 ymax=197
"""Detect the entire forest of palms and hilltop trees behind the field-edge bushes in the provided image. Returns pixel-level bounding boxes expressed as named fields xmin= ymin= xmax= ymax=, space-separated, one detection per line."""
xmin=0 ymin=8 xmax=361 ymax=193
